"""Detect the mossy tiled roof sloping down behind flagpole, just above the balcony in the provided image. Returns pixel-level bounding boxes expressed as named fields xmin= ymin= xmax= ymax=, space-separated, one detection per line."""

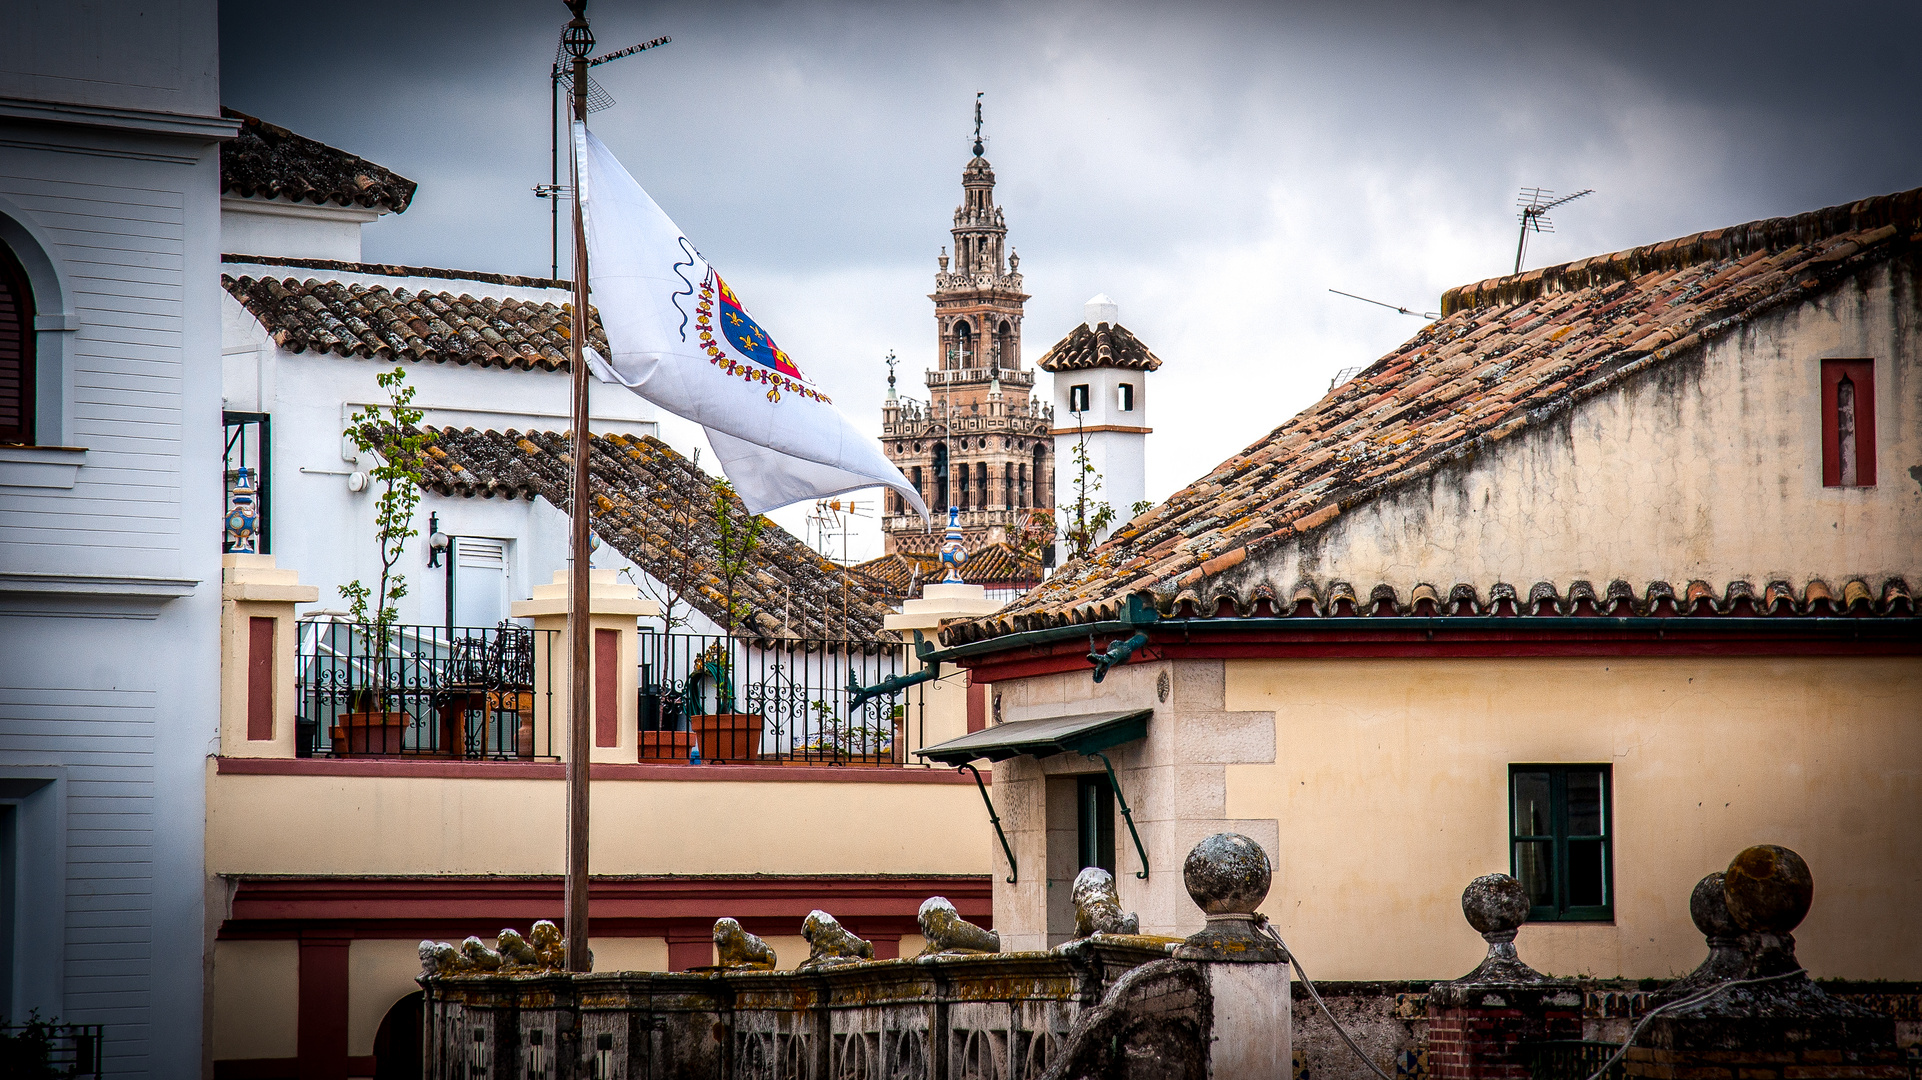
xmin=423 ymin=429 xmax=896 ymax=642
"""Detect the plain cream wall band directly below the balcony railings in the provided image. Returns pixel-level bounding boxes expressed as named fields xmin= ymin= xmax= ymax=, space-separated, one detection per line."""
xmin=208 ymin=761 xmax=994 ymax=874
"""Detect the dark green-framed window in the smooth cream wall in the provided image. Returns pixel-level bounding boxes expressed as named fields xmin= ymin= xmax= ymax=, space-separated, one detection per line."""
xmin=1509 ymin=765 xmax=1614 ymax=922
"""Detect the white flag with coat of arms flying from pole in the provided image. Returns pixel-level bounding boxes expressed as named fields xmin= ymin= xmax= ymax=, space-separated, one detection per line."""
xmin=575 ymin=121 xmax=928 ymax=519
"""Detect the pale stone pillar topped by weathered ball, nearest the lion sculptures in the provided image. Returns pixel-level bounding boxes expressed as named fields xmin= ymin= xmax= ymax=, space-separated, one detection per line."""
xmin=1174 ymin=832 xmax=1294 ymax=1080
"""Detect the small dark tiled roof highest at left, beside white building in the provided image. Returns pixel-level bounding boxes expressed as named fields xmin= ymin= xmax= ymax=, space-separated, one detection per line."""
xmin=221 ymin=108 xmax=419 ymax=213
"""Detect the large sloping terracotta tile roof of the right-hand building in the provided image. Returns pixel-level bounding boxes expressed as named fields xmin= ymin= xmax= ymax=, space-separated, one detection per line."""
xmin=948 ymin=188 xmax=1922 ymax=642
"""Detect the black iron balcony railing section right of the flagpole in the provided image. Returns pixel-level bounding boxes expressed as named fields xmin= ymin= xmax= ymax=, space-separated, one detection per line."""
xmin=640 ymin=632 xmax=923 ymax=765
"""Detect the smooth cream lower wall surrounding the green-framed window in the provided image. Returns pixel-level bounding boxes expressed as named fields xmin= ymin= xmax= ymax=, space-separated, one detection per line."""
xmin=1224 ymin=657 xmax=1922 ymax=980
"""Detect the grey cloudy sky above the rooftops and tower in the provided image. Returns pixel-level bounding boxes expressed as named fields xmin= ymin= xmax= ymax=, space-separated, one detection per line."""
xmin=221 ymin=0 xmax=1922 ymax=557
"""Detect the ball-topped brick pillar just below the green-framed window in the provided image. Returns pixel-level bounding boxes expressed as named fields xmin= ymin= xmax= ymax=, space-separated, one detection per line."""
xmin=1428 ymin=874 xmax=1582 ymax=1080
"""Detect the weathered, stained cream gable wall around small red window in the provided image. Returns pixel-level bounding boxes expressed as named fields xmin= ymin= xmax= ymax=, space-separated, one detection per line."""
xmin=1220 ymin=265 xmax=1922 ymax=600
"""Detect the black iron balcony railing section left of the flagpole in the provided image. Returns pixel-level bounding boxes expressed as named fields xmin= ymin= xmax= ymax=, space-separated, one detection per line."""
xmin=294 ymin=619 xmax=559 ymax=761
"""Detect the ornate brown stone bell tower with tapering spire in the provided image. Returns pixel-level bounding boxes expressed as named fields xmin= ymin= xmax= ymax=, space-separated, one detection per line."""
xmin=880 ymin=94 xmax=1055 ymax=553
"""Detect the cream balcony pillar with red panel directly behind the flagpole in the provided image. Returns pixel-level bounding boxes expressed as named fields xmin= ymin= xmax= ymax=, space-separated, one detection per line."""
xmin=513 ymin=571 xmax=661 ymax=763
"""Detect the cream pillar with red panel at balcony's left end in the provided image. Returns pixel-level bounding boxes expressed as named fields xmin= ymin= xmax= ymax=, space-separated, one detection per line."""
xmin=221 ymin=553 xmax=321 ymax=757
